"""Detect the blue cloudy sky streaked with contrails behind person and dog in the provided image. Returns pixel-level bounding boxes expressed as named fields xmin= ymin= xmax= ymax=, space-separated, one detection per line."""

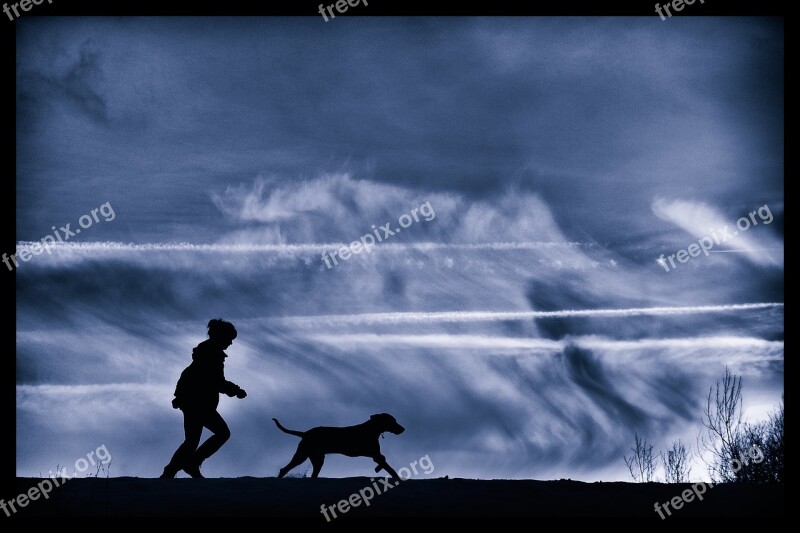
xmin=15 ymin=16 xmax=784 ymax=481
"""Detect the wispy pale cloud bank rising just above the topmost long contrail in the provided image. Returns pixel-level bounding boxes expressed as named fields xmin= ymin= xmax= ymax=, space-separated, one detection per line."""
xmin=212 ymin=173 xmax=579 ymax=243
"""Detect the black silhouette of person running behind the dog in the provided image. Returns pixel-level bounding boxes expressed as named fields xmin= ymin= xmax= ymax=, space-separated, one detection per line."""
xmin=156 ymin=319 xmax=247 ymax=478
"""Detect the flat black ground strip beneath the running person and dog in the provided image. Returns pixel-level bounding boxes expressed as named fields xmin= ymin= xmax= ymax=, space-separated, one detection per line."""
xmin=6 ymin=477 xmax=784 ymax=522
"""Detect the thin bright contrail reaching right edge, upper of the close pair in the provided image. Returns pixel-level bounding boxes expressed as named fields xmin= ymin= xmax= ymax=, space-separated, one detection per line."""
xmin=276 ymin=303 xmax=783 ymax=325
